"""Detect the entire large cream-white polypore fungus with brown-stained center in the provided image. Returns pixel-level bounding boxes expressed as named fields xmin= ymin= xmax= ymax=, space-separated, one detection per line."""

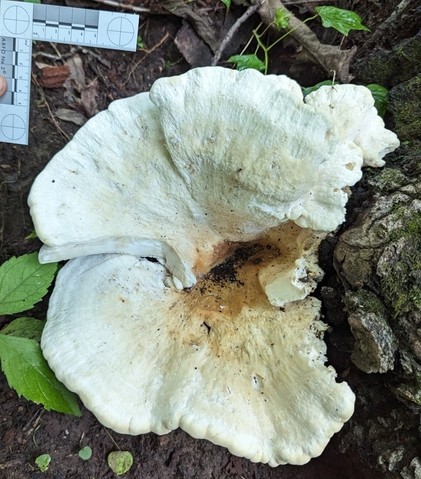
xmin=29 ymin=68 xmax=398 ymax=466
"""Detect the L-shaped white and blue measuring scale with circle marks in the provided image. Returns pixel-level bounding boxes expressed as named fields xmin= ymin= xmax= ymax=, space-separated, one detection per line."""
xmin=0 ymin=0 xmax=139 ymax=145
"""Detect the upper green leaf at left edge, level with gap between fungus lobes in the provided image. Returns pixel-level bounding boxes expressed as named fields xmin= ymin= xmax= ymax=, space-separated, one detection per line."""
xmin=0 ymin=253 xmax=57 ymax=314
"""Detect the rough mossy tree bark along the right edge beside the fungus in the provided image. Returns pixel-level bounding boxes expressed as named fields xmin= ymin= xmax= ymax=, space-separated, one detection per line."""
xmin=335 ymin=33 xmax=421 ymax=479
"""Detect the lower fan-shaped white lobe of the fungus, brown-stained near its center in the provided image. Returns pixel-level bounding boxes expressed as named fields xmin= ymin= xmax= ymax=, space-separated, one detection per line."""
xmin=42 ymin=242 xmax=354 ymax=466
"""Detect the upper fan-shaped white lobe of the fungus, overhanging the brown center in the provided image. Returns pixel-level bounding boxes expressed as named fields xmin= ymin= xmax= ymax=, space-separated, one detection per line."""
xmin=29 ymin=68 xmax=384 ymax=287
